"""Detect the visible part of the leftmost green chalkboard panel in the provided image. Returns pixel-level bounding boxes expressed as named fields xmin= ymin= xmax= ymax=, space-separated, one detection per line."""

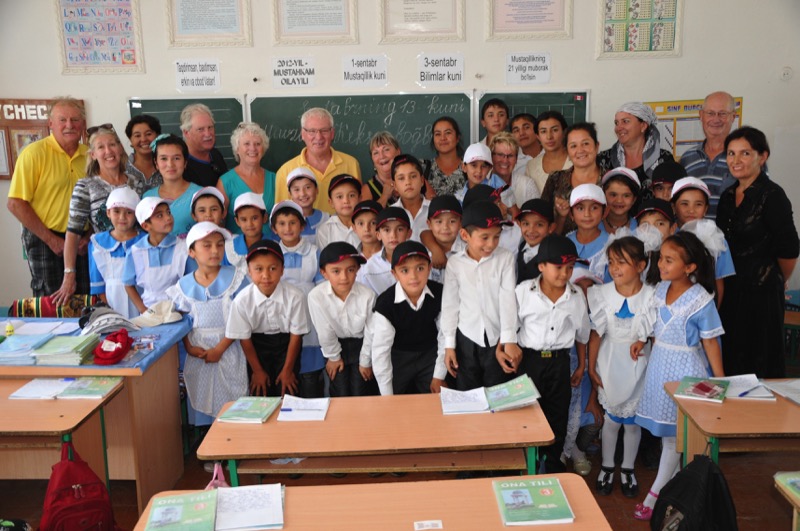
xmin=128 ymin=98 xmax=244 ymax=168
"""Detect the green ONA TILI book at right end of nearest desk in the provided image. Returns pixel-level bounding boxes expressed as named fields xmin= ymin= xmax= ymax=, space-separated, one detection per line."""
xmin=492 ymin=478 xmax=575 ymax=526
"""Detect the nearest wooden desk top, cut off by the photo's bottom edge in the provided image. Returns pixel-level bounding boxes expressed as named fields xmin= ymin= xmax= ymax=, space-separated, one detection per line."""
xmin=134 ymin=474 xmax=611 ymax=531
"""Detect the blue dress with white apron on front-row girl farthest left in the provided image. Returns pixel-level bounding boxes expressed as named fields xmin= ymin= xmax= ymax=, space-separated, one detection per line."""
xmin=167 ymin=266 xmax=248 ymax=425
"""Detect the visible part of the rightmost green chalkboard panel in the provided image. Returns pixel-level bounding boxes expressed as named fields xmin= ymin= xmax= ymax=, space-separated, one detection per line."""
xmin=476 ymin=92 xmax=586 ymax=138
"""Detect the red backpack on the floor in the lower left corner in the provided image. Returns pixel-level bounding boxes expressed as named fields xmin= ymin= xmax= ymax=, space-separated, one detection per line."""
xmin=39 ymin=442 xmax=116 ymax=531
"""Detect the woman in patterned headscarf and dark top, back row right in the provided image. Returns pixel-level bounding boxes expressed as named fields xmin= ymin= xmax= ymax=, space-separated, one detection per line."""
xmin=597 ymin=101 xmax=675 ymax=199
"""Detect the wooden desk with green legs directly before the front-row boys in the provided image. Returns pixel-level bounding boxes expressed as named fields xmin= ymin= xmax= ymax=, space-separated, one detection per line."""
xmin=197 ymin=394 xmax=553 ymax=484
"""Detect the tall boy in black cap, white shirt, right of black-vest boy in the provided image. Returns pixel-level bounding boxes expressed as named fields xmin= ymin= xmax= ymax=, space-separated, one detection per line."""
xmin=441 ymin=201 xmax=521 ymax=391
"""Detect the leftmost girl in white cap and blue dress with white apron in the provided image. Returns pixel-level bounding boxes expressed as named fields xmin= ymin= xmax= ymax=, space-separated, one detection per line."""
xmin=89 ymin=186 xmax=145 ymax=318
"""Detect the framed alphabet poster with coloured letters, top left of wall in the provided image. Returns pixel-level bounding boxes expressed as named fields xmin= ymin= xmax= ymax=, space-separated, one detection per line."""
xmin=54 ymin=0 xmax=144 ymax=74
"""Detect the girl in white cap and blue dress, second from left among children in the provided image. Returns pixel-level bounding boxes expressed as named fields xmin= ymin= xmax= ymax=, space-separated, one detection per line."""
xmin=122 ymin=197 xmax=189 ymax=313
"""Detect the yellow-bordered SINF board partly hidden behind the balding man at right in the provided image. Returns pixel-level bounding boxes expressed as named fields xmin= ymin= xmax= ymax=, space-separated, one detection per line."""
xmin=645 ymin=98 xmax=743 ymax=159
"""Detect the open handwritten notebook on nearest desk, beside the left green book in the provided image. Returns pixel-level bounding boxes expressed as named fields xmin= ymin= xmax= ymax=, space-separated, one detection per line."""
xmin=214 ymin=483 xmax=283 ymax=531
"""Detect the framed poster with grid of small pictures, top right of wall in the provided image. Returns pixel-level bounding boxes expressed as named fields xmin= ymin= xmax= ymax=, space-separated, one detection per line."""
xmin=597 ymin=0 xmax=683 ymax=59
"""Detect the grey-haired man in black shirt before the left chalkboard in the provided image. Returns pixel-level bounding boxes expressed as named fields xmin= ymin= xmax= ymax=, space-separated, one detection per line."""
xmin=181 ymin=103 xmax=228 ymax=187
